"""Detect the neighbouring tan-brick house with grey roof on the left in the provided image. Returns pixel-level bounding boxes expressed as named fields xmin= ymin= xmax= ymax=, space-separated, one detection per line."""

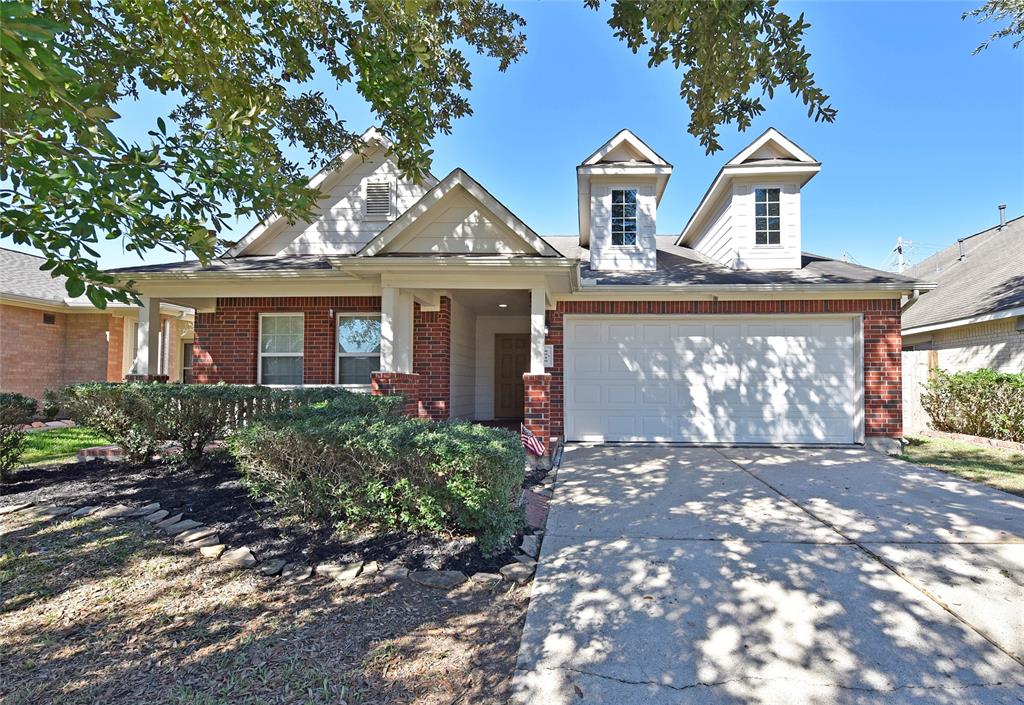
xmin=0 ymin=248 xmax=195 ymax=400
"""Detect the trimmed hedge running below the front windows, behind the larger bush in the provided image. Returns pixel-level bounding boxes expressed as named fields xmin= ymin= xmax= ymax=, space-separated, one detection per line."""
xmin=59 ymin=382 xmax=398 ymax=463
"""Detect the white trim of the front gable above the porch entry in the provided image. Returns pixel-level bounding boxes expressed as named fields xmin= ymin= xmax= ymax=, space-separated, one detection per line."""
xmin=356 ymin=169 xmax=562 ymax=257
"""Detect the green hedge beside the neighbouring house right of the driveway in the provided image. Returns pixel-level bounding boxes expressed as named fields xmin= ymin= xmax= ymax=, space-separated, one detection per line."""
xmin=921 ymin=370 xmax=1024 ymax=441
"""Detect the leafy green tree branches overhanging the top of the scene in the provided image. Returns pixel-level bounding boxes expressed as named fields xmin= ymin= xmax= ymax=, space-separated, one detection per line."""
xmin=0 ymin=0 xmax=836 ymax=306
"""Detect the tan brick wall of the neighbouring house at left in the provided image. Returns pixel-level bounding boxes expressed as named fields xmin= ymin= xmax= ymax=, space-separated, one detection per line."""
xmin=0 ymin=304 xmax=113 ymax=400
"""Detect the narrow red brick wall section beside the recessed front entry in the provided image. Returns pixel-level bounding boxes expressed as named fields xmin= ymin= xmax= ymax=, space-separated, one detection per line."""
xmin=413 ymin=296 xmax=452 ymax=420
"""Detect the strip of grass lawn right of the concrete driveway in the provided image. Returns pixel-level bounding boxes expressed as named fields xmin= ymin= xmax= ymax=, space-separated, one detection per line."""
xmin=900 ymin=437 xmax=1024 ymax=497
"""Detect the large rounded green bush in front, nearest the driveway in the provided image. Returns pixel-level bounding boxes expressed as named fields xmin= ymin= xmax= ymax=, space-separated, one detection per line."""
xmin=228 ymin=401 xmax=525 ymax=551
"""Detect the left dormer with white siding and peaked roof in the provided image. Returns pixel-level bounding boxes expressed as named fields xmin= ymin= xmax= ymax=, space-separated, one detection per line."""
xmin=577 ymin=130 xmax=672 ymax=272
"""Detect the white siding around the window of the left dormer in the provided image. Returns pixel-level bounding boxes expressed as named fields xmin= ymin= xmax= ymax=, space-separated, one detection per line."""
xmin=590 ymin=179 xmax=657 ymax=272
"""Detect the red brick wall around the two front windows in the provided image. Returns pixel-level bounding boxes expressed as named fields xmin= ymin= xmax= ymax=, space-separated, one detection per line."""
xmin=193 ymin=296 xmax=381 ymax=384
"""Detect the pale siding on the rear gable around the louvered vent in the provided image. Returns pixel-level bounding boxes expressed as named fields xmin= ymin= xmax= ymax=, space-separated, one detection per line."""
xmin=247 ymin=149 xmax=429 ymax=255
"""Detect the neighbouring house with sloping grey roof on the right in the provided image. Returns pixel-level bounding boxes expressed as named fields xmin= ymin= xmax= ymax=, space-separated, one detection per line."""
xmin=903 ymin=216 xmax=1024 ymax=431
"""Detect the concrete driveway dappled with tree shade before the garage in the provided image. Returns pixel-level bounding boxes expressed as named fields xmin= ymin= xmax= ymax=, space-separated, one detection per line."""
xmin=513 ymin=446 xmax=1024 ymax=705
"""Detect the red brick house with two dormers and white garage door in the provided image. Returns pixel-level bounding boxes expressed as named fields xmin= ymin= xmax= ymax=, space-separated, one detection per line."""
xmin=110 ymin=129 xmax=923 ymax=448
